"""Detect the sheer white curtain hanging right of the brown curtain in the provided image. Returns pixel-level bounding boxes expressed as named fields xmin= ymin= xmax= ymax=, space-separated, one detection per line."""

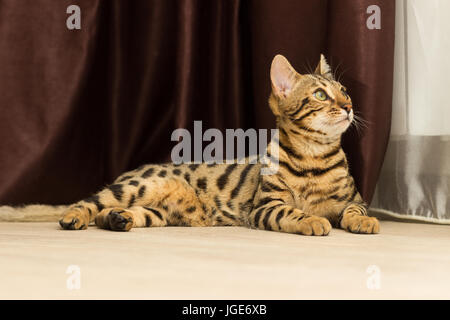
xmin=372 ymin=0 xmax=450 ymax=223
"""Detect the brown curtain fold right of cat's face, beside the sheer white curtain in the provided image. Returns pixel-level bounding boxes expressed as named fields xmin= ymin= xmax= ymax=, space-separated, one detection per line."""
xmin=327 ymin=0 xmax=395 ymax=203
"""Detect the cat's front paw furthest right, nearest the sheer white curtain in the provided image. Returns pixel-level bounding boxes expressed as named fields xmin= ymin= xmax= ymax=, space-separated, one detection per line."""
xmin=339 ymin=203 xmax=380 ymax=233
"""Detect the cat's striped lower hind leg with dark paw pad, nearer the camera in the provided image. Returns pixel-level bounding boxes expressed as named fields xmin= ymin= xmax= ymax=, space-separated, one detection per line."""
xmin=95 ymin=206 xmax=168 ymax=231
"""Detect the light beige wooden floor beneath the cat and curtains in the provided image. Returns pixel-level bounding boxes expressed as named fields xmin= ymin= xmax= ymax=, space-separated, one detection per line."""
xmin=0 ymin=222 xmax=450 ymax=299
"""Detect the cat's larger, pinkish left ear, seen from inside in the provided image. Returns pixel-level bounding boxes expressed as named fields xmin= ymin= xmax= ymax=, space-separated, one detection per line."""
xmin=270 ymin=54 xmax=300 ymax=98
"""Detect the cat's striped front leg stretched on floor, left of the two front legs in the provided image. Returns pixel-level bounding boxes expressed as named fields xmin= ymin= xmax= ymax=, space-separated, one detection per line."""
xmin=249 ymin=199 xmax=331 ymax=236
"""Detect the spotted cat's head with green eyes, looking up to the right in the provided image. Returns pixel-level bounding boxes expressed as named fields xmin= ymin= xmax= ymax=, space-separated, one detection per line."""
xmin=269 ymin=55 xmax=354 ymax=137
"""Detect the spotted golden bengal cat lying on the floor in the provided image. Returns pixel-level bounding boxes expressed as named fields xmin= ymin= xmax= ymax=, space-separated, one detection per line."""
xmin=0 ymin=55 xmax=380 ymax=236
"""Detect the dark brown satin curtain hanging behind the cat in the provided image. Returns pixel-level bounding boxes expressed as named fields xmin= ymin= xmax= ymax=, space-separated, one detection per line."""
xmin=0 ymin=0 xmax=394 ymax=204
